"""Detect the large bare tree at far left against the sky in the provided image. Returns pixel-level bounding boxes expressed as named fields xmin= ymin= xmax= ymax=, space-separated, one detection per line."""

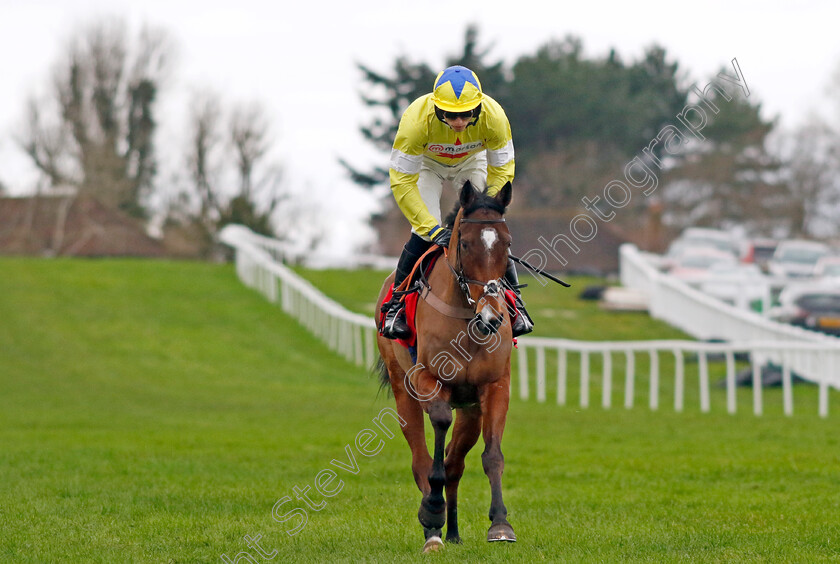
xmin=18 ymin=16 xmax=172 ymax=217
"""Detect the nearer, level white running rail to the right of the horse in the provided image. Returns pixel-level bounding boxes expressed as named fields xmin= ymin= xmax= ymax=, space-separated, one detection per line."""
xmin=517 ymin=337 xmax=840 ymax=417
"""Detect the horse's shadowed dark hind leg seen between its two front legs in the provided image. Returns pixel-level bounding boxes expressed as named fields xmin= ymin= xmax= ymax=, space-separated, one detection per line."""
xmin=444 ymin=406 xmax=481 ymax=543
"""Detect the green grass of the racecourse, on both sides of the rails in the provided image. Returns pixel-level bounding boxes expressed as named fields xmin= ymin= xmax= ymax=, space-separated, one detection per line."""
xmin=0 ymin=258 xmax=840 ymax=563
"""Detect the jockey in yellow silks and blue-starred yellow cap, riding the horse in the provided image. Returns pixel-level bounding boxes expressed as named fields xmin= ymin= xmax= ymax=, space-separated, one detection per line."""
xmin=380 ymin=66 xmax=533 ymax=339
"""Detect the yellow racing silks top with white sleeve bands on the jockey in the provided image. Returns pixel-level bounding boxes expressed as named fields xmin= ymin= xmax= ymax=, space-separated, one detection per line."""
xmin=390 ymin=94 xmax=514 ymax=235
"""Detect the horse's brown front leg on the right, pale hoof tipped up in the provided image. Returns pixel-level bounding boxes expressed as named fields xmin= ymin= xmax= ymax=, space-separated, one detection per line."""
xmin=481 ymin=378 xmax=516 ymax=542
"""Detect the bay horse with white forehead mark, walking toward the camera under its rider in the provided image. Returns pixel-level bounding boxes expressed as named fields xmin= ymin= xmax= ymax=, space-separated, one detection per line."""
xmin=376 ymin=182 xmax=516 ymax=552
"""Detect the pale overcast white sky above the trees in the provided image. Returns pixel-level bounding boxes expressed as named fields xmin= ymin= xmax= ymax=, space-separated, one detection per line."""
xmin=0 ymin=0 xmax=840 ymax=248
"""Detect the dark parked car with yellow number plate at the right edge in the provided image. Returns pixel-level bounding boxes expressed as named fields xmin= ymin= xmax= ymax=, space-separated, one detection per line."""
xmin=770 ymin=284 xmax=840 ymax=335
